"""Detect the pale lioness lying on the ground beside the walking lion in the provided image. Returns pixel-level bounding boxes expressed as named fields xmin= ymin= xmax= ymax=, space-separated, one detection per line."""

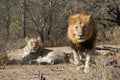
xmin=21 ymin=37 xmax=67 ymax=64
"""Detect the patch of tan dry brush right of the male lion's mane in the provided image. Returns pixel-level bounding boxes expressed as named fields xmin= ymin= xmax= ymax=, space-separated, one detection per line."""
xmin=97 ymin=27 xmax=120 ymax=45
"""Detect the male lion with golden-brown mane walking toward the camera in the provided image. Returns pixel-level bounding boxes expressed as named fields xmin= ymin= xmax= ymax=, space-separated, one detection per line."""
xmin=67 ymin=12 xmax=97 ymax=73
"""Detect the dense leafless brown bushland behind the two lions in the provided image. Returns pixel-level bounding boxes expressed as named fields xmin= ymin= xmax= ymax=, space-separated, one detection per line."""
xmin=0 ymin=0 xmax=120 ymax=51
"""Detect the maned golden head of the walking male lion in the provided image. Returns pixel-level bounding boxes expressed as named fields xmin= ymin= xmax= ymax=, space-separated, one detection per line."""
xmin=68 ymin=12 xmax=94 ymax=42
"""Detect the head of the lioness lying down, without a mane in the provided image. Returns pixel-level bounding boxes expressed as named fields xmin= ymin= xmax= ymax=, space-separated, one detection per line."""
xmin=25 ymin=37 xmax=41 ymax=52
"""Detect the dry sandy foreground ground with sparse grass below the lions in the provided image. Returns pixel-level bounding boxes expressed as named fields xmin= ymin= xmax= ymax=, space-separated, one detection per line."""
xmin=0 ymin=45 xmax=120 ymax=80
